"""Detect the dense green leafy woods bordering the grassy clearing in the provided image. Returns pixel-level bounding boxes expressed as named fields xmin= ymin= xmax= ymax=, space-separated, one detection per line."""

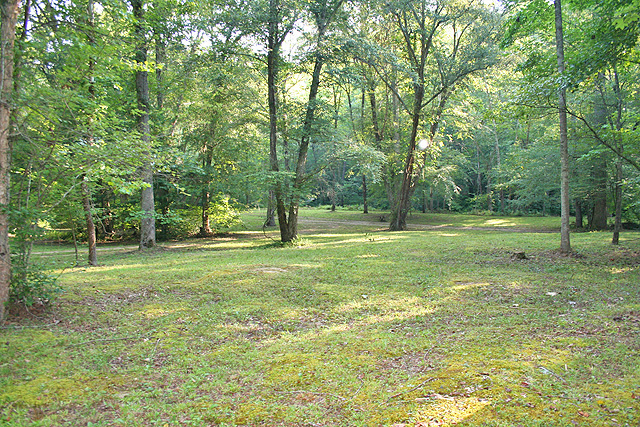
xmin=0 ymin=0 xmax=640 ymax=316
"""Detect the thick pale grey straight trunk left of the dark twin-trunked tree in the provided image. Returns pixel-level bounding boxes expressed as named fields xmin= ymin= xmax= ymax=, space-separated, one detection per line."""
xmin=131 ymin=0 xmax=156 ymax=250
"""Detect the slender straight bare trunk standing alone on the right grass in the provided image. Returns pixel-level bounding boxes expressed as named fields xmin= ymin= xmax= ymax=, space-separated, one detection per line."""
xmin=554 ymin=0 xmax=571 ymax=254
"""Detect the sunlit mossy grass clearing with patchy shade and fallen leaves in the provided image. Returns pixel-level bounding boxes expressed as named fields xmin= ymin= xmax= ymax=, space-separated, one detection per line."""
xmin=0 ymin=210 xmax=640 ymax=426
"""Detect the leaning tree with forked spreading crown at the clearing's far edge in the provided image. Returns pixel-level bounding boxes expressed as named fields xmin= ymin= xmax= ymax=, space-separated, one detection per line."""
xmin=368 ymin=0 xmax=497 ymax=230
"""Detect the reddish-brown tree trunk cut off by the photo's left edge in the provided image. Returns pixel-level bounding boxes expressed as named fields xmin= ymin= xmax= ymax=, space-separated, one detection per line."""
xmin=0 ymin=0 xmax=20 ymax=321
